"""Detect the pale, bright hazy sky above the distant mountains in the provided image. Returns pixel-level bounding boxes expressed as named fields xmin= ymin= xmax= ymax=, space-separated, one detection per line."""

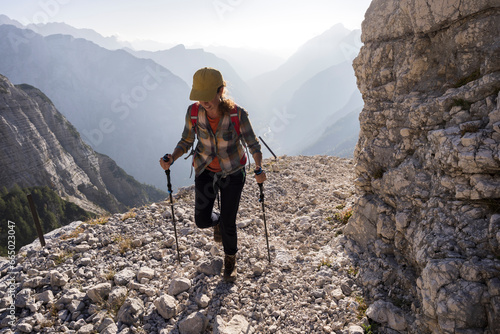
xmin=0 ymin=0 xmax=371 ymax=56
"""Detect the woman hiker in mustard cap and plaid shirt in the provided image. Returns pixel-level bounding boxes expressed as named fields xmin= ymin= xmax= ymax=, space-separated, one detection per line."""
xmin=160 ymin=67 xmax=266 ymax=282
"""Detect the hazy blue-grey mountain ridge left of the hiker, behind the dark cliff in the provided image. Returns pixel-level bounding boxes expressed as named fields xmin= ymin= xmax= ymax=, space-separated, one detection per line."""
xmin=0 ymin=25 xmax=189 ymax=187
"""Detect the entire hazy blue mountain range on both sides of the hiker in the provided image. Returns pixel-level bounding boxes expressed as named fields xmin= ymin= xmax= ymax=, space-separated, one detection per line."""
xmin=0 ymin=15 xmax=363 ymax=188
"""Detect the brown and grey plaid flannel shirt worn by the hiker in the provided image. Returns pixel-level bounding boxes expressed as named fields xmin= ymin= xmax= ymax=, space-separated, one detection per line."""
xmin=176 ymin=104 xmax=261 ymax=177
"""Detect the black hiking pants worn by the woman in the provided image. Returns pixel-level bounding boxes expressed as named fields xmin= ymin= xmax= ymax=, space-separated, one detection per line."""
xmin=194 ymin=168 xmax=246 ymax=255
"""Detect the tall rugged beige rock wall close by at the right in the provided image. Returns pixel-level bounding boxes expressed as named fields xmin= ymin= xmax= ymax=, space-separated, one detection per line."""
xmin=345 ymin=0 xmax=500 ymax=333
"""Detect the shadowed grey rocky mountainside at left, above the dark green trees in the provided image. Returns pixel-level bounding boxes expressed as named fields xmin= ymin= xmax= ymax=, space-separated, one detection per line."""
xmin=0 ymin=75 xmax=165 ymax=212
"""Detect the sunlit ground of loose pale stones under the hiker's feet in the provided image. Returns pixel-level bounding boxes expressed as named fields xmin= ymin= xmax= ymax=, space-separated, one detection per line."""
xmin=0 ymin=156 xmax=368 ymax=334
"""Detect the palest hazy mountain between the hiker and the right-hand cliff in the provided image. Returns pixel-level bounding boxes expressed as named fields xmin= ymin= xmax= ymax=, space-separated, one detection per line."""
xmin=250 ymin=24 xmax=364 ymax=157
